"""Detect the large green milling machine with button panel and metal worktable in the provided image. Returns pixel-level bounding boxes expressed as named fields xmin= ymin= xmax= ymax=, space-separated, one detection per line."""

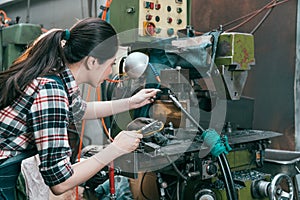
xmin=87 ymin=0 xmax=299 ymax=200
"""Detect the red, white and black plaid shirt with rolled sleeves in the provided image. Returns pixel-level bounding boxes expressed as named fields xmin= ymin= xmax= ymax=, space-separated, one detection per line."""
xmin=0 ymin=69 xmax=86 ymax=186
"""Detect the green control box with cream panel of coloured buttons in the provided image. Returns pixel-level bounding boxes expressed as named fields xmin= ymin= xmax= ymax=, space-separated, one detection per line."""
xmin=109 ymin=0 xmax=191 ymax=44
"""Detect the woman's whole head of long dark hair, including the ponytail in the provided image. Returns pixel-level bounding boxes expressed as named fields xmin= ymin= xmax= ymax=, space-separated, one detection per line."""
xmin=0 ymin=18 xmax=118 ymax=109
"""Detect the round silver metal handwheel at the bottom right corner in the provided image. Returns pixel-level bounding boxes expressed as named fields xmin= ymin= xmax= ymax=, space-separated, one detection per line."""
xmin=269 ymin=173 xmax=294 ymax=200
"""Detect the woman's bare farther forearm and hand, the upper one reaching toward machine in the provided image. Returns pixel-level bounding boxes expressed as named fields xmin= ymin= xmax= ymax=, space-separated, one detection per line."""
xmin=83 ymin=89 xmax=160 ymax=119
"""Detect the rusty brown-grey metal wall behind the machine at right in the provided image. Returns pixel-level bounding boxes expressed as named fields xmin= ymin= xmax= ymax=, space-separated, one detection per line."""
xmin=191 ymin=0 xmax=297 ymax=150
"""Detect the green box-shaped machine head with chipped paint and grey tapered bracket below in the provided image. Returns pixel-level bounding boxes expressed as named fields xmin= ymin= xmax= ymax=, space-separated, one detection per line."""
xmin=215 ymin=32 xmax=255 ymax=100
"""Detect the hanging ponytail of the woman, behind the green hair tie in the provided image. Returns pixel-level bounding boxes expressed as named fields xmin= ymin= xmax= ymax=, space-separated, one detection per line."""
xmin=0 ymin=29 xmax=64 ymax=109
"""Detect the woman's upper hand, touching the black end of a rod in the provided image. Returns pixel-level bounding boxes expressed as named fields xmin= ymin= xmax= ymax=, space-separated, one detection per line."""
xmin=129 ymin=89 xmax=160 ymax=109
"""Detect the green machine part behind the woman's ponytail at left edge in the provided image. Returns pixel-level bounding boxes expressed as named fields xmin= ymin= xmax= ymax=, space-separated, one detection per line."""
xmin=0 ymin=23 xmax=42 ymax=70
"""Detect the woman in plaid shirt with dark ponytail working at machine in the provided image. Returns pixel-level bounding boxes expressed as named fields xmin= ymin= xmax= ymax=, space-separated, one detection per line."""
xmin=0 ymin=18 xmax=157 ymax=199
